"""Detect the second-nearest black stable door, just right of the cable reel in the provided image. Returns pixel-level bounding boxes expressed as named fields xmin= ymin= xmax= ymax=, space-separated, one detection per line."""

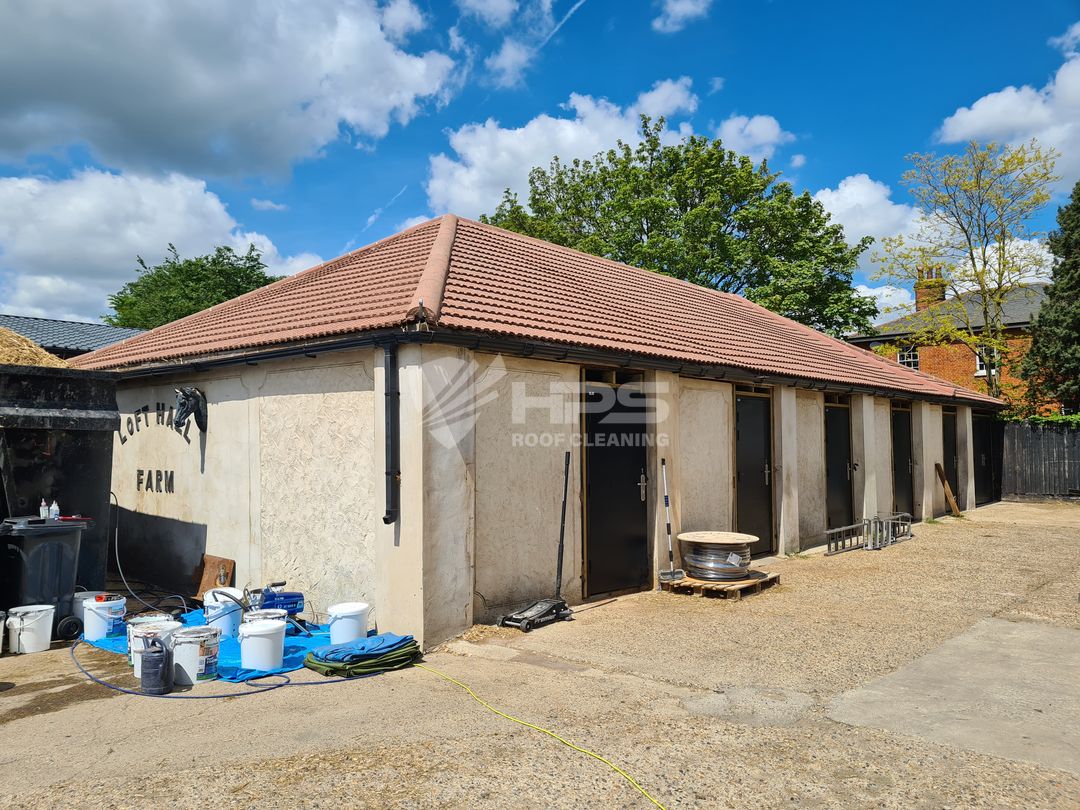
xmin=735 ymin=395 xmax=773 ymax=554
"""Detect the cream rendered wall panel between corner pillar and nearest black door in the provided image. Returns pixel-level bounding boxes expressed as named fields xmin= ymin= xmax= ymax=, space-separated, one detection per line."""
xmin=473 ymin=353 xmax=583 ymax=620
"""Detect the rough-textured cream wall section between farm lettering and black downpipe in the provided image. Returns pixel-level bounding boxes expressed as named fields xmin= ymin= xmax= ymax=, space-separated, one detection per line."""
xmin=253 ymin=351 xmax=382 ymax=619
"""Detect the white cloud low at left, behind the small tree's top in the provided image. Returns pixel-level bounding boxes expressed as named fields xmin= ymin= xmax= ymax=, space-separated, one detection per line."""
xmin=0 ymin=171 xmax=321 ymax=319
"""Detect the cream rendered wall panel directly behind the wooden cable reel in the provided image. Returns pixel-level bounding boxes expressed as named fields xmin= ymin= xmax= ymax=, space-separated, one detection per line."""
xmin=673 ymin=379 xmax=734 ymax=540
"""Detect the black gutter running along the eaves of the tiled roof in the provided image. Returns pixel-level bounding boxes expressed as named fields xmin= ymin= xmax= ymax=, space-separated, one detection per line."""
xmin=101 ymin=328 xmax=1005 ymax=409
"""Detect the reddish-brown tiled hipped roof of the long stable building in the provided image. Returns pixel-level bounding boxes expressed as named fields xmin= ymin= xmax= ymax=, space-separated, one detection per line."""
xmin=76 ymin=215 xmax=997 ymax=403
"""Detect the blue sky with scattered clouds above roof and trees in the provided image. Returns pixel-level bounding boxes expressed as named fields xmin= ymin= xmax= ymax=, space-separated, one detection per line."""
xmin=0 ymin=0 xmax=1080 ymax=320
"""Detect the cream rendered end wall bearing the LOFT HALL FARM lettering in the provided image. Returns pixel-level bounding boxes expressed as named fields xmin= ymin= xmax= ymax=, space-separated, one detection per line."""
xmin=112 ymin=350 xmax=381 ymax=626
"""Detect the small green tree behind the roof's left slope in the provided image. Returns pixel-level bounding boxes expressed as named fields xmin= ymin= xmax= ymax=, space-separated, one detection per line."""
xmin=104 ymin=244 xmax=281 ymax=329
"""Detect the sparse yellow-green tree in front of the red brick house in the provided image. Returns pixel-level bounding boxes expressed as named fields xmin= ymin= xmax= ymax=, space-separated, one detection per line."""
xmin=875 ymin=140 xmax=1058 ymax=396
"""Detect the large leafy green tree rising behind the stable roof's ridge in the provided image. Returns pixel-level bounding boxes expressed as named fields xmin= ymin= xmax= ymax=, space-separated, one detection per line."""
xmin=481 ymin=116 xmax=877 ymax=335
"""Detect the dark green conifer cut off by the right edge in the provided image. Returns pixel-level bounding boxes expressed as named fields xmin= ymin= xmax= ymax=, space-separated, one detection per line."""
xmin=1021 ymin=183 xmax=1080 ymax=414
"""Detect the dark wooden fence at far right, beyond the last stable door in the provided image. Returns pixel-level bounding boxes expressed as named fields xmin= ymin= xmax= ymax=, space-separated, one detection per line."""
xmin=1001 ymin=422 xmax=1080 ymax=498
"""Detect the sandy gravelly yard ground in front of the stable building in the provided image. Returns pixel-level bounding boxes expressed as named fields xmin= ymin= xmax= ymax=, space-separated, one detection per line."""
xmin=0 ymin=503 xmax=1080 ymax=808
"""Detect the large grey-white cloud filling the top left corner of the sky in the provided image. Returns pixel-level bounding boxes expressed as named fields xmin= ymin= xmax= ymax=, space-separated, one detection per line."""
xmin=0 ymin=0 xmax=454 ymax=175
